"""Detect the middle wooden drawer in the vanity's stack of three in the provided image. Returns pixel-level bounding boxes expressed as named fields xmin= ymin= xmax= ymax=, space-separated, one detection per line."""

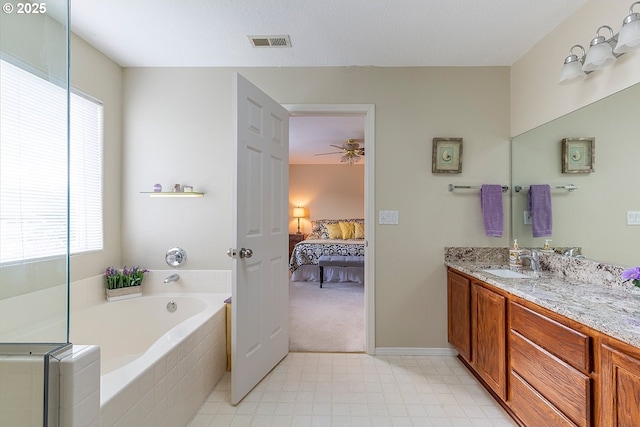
xmin=510 ymin=331 xmax=591 ymax=426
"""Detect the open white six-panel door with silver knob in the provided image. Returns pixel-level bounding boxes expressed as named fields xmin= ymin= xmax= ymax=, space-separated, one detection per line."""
xmin=230 ymin=73 xmax=289 ymax=405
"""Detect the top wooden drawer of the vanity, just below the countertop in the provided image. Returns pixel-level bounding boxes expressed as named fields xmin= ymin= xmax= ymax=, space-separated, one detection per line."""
xmin=510 ymin=302 xmax=591 ymax=373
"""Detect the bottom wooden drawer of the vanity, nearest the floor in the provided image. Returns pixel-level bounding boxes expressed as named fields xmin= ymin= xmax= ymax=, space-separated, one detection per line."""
xmin=509 ymin=372 xmax=575 ymax=427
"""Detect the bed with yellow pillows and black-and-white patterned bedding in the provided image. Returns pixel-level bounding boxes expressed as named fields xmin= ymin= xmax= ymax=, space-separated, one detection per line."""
xmin=289 ymin=219 xmax=364 ymax=283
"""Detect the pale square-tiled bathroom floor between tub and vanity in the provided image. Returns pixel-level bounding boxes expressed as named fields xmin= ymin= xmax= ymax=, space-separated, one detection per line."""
xmin=188 ymin=353 xmax=516 ymax=427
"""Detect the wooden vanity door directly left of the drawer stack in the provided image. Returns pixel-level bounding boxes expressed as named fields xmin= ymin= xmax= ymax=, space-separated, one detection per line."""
xmin=471 ymin=283 xmax=507 ymax=400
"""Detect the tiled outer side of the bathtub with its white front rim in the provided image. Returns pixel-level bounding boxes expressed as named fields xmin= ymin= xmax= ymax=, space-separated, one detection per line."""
xmin=100 ymin=297 xmax=227 ymax=427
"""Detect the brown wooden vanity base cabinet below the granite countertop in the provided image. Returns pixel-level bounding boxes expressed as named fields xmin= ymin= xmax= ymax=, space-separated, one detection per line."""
xmin=447 ymin=269 xmax=640 ymax=427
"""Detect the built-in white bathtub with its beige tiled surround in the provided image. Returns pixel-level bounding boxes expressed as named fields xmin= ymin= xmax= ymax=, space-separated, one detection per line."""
xmin=71 ymin=270 xmax=231 ymax=426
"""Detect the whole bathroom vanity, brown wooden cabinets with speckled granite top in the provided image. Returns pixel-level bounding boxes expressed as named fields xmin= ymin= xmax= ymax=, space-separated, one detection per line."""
xmin=445 ymin=261 xmax=640 ymax=427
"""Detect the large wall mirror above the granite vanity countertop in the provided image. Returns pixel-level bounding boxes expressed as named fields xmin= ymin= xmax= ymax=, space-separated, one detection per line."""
xmin=511 ymin=84 xmax=640 ymax=266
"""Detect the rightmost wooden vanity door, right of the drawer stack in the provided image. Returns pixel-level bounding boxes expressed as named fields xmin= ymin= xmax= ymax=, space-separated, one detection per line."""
xmin=600 ymin=344 xmax=640 ymax=427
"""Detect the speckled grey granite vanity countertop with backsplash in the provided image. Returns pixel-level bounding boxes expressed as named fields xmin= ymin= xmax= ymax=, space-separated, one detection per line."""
xmin=445 ymin=248 xmax=640 ymax=348
